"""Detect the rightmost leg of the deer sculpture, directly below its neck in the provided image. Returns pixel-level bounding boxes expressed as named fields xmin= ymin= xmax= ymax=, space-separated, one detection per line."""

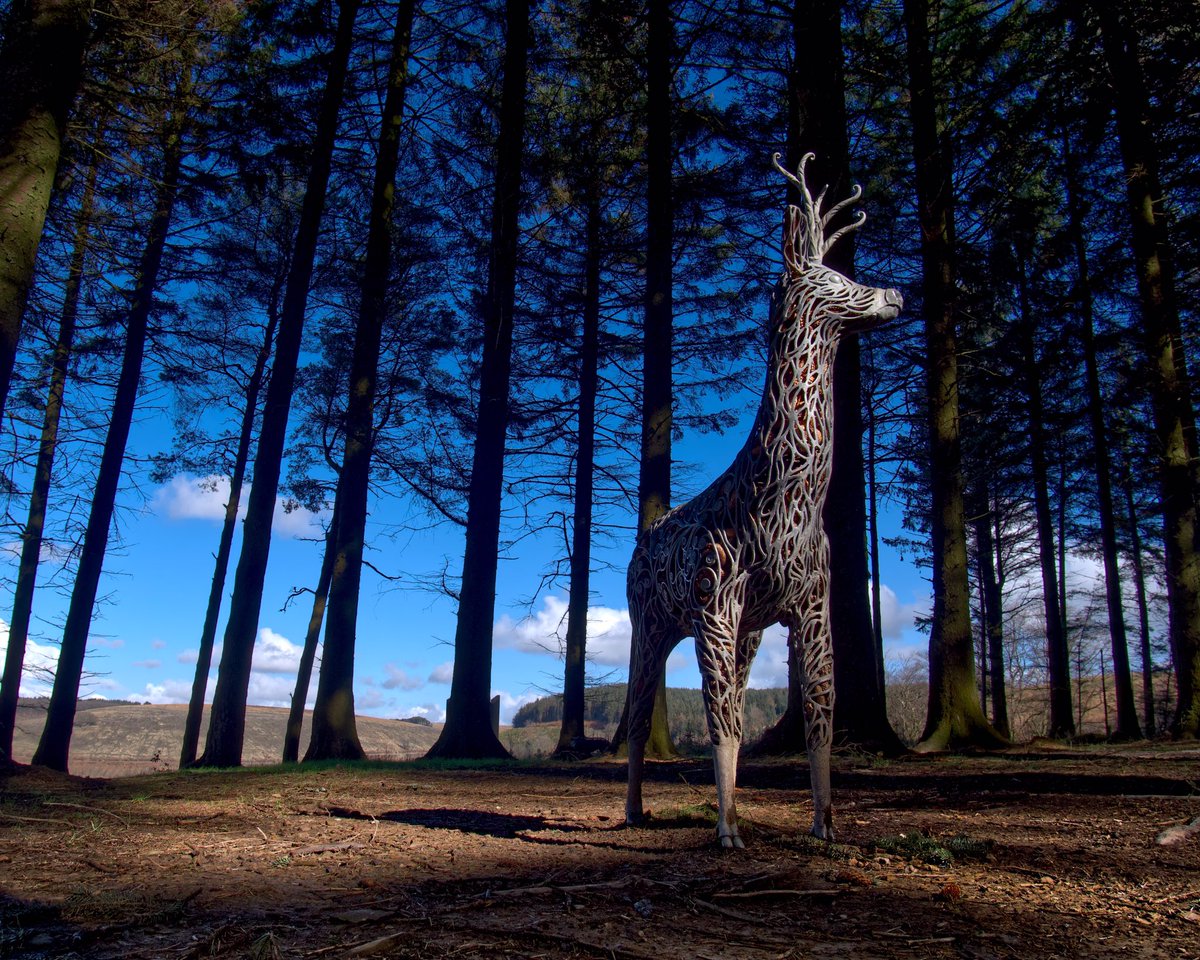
xmin=790 ymin=592 xmax=834 ymax=840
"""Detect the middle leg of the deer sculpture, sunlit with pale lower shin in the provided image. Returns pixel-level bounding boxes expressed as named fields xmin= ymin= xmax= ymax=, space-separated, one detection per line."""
xmin=694 ymin=608 xmax=757 ymax=848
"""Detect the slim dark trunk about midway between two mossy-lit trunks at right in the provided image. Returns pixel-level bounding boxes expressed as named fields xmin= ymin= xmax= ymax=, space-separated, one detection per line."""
xmin=1018 ymin=273 xmax=1075 ymax=738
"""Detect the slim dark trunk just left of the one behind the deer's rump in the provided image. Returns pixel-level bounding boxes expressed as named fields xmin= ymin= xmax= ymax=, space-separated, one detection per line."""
xmin=556 ymin=180 xmax=600 ymax=754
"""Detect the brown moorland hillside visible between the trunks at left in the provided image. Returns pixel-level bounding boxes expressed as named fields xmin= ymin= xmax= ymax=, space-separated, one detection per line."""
xmin=13 ymin=698 xmax=440 ymax=776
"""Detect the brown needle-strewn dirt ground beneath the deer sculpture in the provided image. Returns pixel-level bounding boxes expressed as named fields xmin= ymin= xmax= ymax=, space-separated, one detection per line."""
xmin=0 ymin=745 xmax=1200 ymax=960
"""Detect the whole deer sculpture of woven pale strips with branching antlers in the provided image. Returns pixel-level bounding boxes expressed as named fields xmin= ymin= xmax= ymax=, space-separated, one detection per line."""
xmin=625 ymin=154 xmax=904 ymax=847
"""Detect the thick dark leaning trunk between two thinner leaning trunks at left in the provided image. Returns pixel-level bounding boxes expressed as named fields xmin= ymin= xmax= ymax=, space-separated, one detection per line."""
xmin=197 ymin=0 xmax=360 ymax=767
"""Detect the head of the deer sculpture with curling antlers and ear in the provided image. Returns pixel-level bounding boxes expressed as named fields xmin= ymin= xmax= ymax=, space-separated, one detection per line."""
xmin=772 ymin=154 xmax=904 ymax=332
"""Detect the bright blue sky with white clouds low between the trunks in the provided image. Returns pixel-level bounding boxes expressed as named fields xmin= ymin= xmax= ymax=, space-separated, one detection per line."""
xmin=0 ymin=405 xmax=928 ymax=721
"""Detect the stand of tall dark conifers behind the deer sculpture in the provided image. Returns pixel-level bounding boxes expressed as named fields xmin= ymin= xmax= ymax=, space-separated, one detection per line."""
xmin=0 ymin=0 xmax=1200 ymax=768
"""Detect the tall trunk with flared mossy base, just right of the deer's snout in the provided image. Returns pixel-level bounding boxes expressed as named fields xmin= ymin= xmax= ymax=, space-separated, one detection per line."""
xmin=904 ymin=0 xmax=1006 ymax=750
